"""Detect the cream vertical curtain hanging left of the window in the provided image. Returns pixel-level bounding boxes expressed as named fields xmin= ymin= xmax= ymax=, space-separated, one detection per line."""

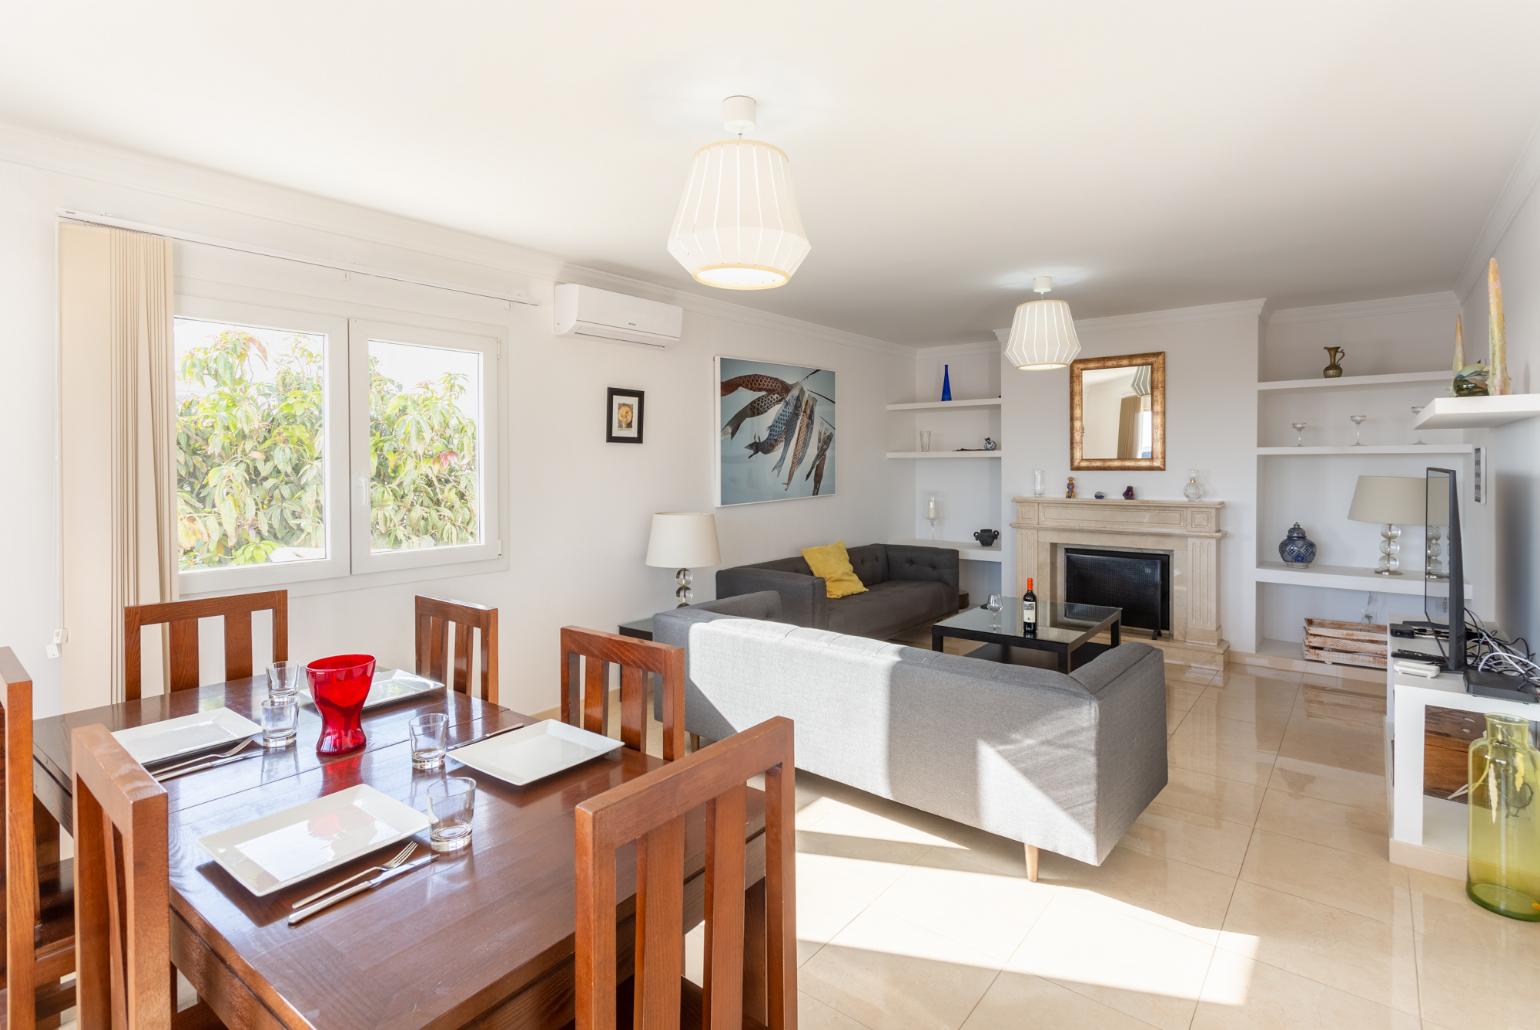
xmin=59 ymin=222 xmax=177 ymax=711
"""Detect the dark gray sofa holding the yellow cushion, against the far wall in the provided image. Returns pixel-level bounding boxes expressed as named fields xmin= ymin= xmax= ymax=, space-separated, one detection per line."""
xmin=716 ymin=543 xmax=959 ymax=640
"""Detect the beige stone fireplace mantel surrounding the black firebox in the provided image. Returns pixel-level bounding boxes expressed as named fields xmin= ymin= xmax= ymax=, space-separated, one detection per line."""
xmin=1010 ymin=497 xmax=1229 ymax=667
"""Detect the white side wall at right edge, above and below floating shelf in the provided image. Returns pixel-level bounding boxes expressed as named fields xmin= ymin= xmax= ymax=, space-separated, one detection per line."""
xmin=1461 ymin=162 xmax=1540 ymax=647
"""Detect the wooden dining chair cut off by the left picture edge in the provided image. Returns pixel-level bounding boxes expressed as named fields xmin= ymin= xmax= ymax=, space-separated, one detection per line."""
xmin=0 ymin=647 xmax=75 ymax=1030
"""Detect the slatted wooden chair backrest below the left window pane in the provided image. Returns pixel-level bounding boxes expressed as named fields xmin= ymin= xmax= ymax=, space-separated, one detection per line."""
xmin=123 ymin=590 xmax=288 ymax=701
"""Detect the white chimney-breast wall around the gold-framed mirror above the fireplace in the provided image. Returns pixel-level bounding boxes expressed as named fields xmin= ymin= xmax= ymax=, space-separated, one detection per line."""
xmin=1001 ymin=300 xmax=1261 ymax=651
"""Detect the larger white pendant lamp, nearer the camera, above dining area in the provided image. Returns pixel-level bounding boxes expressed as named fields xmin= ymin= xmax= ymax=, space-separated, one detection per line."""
xmin=668 ymin=97 xmax=812 ymax=289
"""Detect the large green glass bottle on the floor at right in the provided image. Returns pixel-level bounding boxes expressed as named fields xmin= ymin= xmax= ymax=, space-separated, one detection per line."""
xmin=1465 ymin=714 xmax=1540 ymax=922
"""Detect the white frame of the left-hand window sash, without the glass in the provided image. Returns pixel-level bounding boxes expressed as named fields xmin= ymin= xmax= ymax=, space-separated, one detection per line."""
xmin=171 ymin=296 xmax=350 ymax=594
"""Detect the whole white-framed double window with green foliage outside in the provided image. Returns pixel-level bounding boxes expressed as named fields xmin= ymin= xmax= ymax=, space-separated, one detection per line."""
xmin=174 ymin=299 xmax=499 ymax=593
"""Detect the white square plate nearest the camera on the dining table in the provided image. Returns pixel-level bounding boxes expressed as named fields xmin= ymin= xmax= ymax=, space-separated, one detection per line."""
xmin=199 ymin=784 xmax=428 ymax=898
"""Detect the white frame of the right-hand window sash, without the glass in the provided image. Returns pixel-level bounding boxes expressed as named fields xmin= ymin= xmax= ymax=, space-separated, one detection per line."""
xmin=348 ymin=319 xmax=502 ymax=574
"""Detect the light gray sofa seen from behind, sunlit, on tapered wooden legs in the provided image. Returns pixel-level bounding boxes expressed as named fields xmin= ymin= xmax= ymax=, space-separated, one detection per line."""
xmin=653 ymin=591 xmax=1166 ymax=879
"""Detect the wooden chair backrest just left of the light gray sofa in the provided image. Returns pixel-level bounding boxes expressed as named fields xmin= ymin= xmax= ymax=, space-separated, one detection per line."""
xmin=562 ymin=627 xmax=684 ymax=762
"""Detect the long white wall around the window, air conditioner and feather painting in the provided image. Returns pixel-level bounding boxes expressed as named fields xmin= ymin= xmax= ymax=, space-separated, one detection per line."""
xmin=0 ymin=128 xmax=913 ymax=713
